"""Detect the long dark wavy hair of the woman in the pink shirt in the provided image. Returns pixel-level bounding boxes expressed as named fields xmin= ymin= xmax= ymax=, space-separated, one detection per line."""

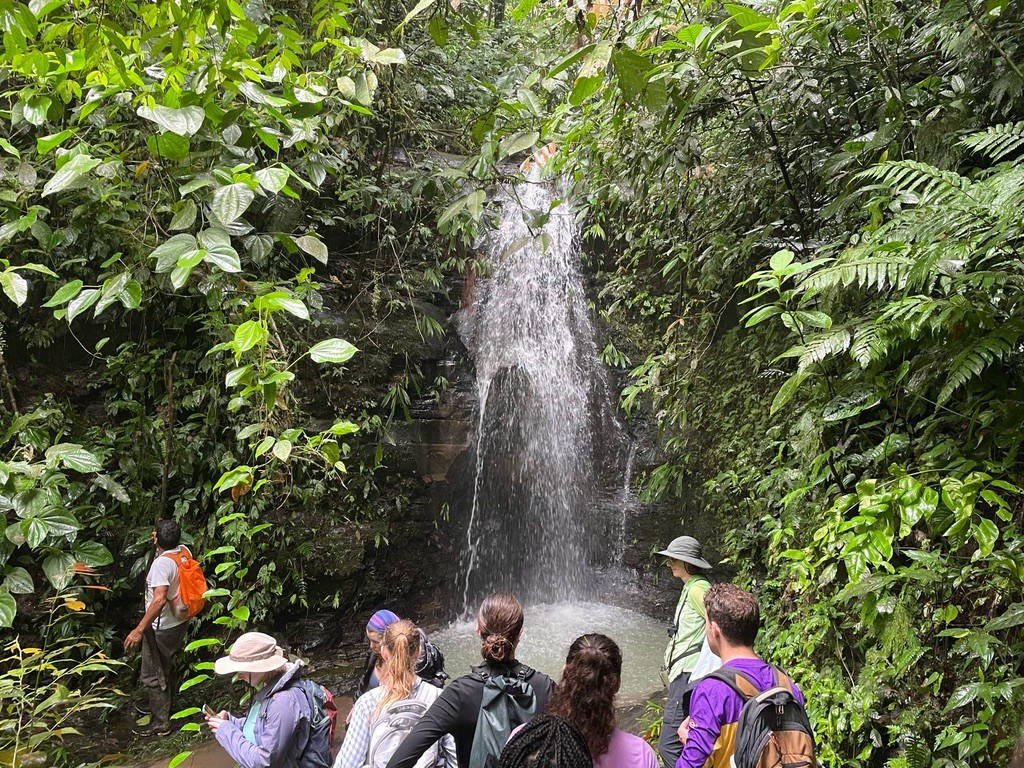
xmin=547 ymin=634 xmax=623 ymax=760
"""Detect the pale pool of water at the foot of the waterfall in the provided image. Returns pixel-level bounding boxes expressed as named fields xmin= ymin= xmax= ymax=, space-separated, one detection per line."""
xmin=430 ymin=602 xmax=668 ymax=707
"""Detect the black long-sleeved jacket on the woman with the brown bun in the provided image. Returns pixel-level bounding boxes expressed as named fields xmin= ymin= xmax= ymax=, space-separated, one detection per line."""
xmin=387 ymin=662 xmax=555 ymax=768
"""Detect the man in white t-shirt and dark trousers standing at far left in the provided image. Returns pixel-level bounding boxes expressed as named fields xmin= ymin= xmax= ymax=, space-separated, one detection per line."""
xmin=125 ymin=520 xmax=188 ymax=736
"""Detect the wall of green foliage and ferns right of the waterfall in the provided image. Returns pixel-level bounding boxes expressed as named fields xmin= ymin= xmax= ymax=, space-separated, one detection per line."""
xmin=499 ymin=0 xmax=1024 ymax=766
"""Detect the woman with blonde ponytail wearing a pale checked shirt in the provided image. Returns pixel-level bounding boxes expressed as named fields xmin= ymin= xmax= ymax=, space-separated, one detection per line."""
xmin=334 ymin=620 xmax=457 ymax=768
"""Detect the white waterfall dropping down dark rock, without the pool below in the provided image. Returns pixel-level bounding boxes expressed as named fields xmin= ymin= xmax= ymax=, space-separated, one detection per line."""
xmin=461 ymin=183 xmax=606 ymax=611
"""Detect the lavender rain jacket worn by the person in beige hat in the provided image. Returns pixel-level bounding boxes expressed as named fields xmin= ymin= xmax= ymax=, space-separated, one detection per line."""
xmin=217 ymin=663 xmax=309 ymax=768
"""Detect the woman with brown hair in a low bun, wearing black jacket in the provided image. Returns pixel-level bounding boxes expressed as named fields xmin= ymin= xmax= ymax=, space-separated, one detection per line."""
xmin=387 ymin=595 xmax=555 ymax=768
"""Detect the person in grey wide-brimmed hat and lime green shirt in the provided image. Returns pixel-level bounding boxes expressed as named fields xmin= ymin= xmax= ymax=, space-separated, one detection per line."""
xmin=657 ymin=536 xmax=711 ymax=768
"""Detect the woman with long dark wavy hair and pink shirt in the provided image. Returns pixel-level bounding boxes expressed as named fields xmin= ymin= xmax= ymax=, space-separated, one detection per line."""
xmin=548 ymin=634 xmax=657 ymax=768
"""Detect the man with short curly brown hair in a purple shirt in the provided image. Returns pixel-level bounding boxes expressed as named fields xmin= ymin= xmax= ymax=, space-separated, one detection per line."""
xmin=676 ymin=584 xmax=804 ymax=768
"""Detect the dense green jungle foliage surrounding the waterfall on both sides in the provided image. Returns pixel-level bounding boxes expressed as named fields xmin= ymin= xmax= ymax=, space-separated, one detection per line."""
xmin=0 ymin=0 xmax=1024 ymax=768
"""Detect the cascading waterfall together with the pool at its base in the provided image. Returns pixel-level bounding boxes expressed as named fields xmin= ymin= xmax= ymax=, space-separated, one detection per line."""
xmin=433 ymin=176 xmax=666 ymax=702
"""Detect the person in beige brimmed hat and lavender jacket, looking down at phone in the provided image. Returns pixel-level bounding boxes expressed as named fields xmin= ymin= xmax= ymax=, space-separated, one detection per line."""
xmin=206 ymin=632 xmax=331 ymax=768
